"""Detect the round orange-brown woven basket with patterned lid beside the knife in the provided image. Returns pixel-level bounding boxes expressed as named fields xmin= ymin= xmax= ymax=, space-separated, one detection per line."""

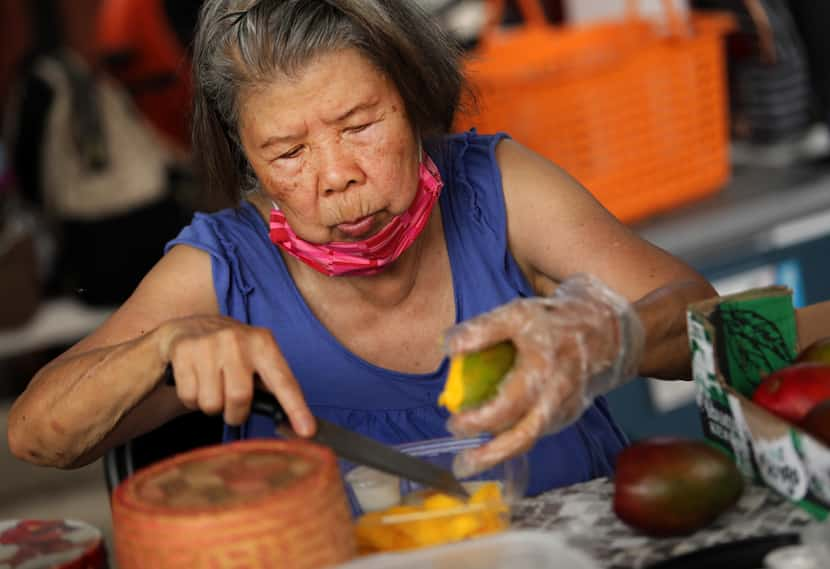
xmin=112 ymin=440 xmax=355 ymax=569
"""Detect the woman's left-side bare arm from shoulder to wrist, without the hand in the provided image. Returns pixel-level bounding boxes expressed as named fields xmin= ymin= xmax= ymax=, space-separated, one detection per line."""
xmin=8 ymin=247 xmax=218 ymax=467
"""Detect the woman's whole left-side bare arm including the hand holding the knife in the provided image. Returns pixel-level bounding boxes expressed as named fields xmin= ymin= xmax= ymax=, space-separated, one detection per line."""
xmin=8 ymin=239 xmax=314 ymax=467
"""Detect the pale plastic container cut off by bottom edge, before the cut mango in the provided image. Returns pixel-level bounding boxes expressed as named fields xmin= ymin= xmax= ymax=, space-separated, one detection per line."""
xmin=336 ymin=531 xmax=600 ymax=569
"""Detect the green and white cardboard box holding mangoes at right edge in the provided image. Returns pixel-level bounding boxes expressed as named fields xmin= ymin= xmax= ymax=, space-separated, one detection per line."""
xmin=687 ymin=287 xmax=830 ymax=520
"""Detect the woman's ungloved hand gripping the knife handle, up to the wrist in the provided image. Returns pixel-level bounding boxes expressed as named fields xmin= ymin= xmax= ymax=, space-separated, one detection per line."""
xmin=159 ymin=316 xmax=315 ymax=436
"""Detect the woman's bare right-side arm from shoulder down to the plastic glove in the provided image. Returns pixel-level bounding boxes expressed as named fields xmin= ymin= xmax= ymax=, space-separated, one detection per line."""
xmin=496 ymin=141 xmax=716 ymax=379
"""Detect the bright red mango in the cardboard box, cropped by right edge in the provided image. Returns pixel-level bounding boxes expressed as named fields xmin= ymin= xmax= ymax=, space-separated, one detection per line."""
xmin=752 ymin=363 xmax=830 ymax=423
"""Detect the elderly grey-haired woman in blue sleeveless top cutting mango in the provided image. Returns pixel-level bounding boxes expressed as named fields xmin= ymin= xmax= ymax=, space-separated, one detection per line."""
xmin=9 ymin=0 xmax=713 ymax=492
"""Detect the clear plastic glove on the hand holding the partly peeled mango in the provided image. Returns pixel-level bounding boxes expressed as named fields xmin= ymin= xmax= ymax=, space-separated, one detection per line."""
xmin=446 ymin=274 xmax=645 ymax=477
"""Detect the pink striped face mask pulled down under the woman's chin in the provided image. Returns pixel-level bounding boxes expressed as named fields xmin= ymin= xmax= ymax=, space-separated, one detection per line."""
xmin=270 ymin=153 xmax=444 ymax=276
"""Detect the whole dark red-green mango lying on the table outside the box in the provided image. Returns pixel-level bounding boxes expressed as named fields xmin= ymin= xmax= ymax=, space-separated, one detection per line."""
xmin=614 ymin=437 xmax=744 ymax=537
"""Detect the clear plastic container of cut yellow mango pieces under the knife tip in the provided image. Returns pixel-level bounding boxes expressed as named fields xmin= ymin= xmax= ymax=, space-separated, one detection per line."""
xmin=344 ymin=437 xmax=528 ymax=553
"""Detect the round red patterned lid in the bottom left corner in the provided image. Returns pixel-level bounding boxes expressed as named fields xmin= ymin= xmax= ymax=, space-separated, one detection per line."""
xmin=0 ymin=519 xmax=107 ymax=569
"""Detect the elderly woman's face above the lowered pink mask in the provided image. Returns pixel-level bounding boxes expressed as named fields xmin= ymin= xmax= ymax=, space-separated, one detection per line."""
xmin=239 ymin=49 xmax=420 ymax=243
